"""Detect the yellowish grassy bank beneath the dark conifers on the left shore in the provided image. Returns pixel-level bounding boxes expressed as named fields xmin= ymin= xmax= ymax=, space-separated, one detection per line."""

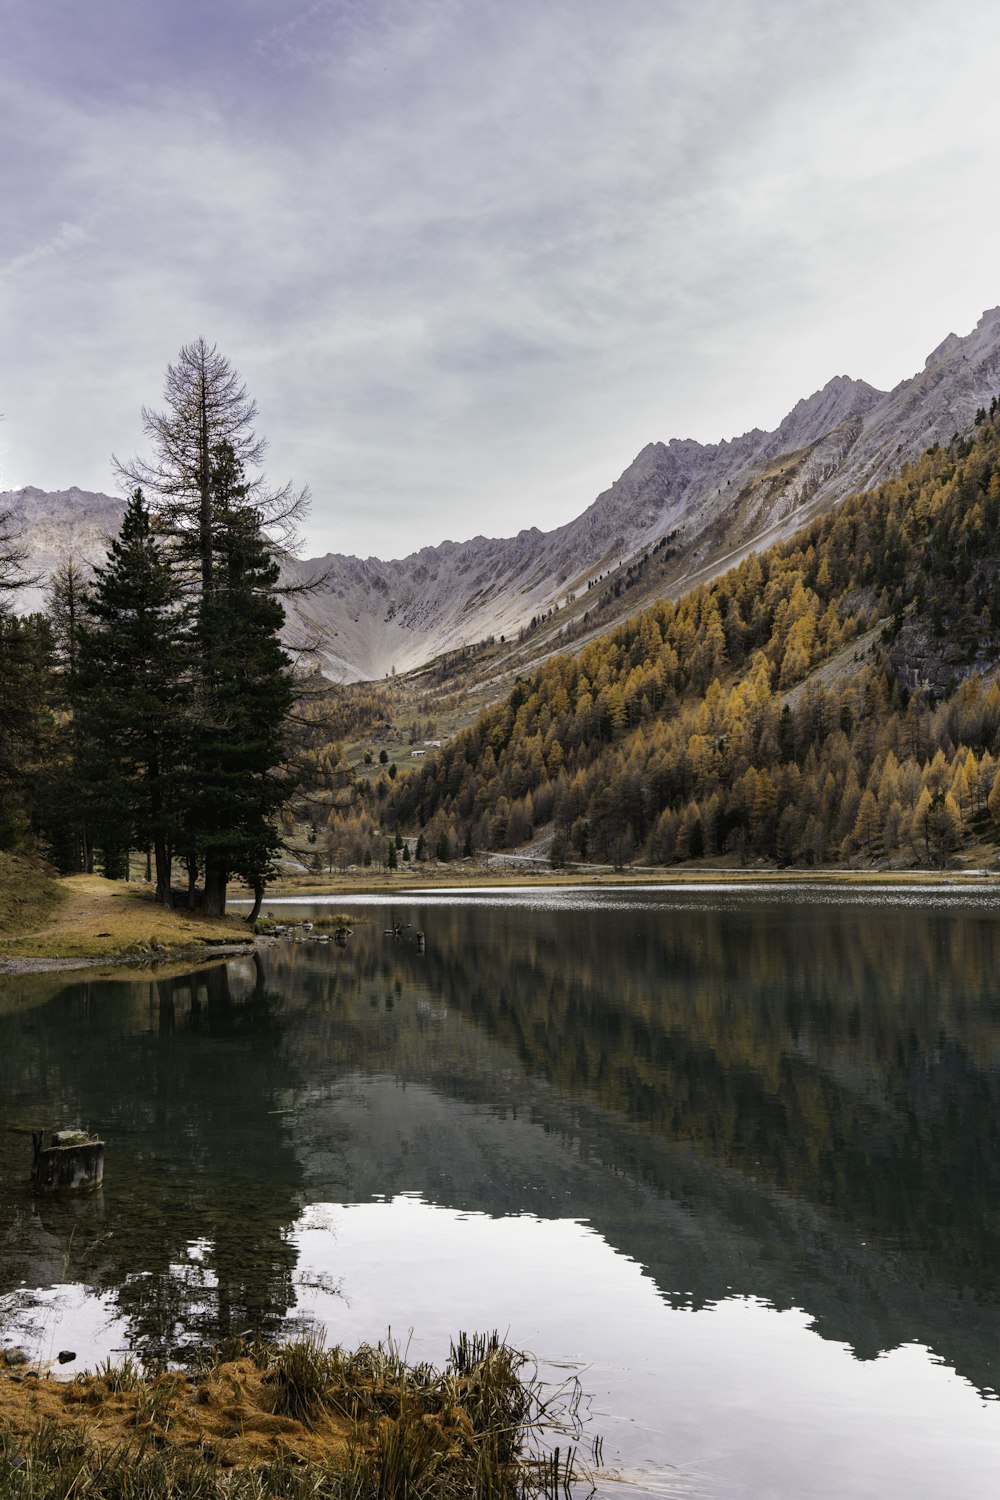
xmin=0 ymin=855 xmax=249 ymax=966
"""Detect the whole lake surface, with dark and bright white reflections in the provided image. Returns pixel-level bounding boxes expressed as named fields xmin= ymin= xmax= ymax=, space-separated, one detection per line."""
xmin=0 ymin=890 xmax=1000 ymax=1500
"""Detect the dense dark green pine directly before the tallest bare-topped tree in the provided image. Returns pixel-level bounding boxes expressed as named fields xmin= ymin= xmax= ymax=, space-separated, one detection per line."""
xmin=186 ymin=443 xmax=292 ymax=921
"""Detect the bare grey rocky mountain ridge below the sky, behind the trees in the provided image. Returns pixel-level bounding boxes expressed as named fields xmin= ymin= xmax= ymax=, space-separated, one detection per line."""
xmin=0 ymin=308 xmax=1000 ymax=681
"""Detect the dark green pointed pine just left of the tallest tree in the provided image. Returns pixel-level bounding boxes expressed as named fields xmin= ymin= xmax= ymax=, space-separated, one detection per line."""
xmin=75 ymin=489 xmax=192 ymax=906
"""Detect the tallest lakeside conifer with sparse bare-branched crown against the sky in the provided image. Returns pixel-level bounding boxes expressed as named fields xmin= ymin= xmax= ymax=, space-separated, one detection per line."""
xmin=115 ymin=339 xmax=307 ymax=915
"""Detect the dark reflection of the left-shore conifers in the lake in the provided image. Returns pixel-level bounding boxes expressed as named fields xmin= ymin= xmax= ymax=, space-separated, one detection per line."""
xmin=0 ymin=963 xmax=300 ymax=1359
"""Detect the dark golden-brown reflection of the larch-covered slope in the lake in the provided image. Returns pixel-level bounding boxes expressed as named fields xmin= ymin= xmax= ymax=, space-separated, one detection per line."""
xmin=260 ymin=903 xmax=1000 ymax=1290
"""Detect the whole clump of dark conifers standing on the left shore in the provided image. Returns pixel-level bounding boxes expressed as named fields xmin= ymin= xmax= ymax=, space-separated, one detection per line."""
xmin=0 ymin=339 xmax=304 ymax=915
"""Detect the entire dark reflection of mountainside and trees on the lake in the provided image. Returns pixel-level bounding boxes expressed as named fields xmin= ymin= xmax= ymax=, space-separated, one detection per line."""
xmin=0 ymin=903 xmax=1000 ymax=1389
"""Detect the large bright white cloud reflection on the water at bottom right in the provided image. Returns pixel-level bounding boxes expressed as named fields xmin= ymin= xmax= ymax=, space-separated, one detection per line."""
xmin=283 ymin=1194 xmax=999 ymax=1500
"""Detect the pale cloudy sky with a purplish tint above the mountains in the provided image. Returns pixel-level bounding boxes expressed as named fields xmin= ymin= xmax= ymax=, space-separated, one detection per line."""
xmin=0 ymin=0 xmax=1000 ymax=558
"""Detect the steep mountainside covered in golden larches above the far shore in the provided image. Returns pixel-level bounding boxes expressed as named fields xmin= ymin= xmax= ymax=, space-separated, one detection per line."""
xmin=384 ymin=399 xmax=1000 ymax=866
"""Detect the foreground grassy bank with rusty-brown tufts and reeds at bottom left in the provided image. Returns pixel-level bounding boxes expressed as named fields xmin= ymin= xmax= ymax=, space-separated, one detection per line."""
xmin=0 ymin=1335 xmax=576 ymax=1500
